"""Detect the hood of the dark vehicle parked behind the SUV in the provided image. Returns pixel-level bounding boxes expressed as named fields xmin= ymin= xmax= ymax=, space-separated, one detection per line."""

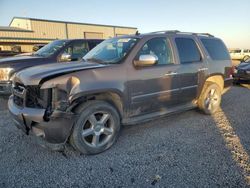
xmin=0 ymin=56 xmax=43 ymax=67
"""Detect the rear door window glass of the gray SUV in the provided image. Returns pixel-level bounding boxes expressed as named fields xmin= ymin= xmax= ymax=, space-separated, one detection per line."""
xmin=175 ymin=38 xmax=201 ymax=64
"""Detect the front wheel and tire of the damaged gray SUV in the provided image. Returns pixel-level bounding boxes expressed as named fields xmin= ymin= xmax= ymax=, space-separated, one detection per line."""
xmin=70 ymin=101 xmax=121 ymax=154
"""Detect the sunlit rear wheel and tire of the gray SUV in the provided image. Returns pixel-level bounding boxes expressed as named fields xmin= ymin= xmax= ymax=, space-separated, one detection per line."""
xmin=198 ymin=82 xmax=221 ymax=115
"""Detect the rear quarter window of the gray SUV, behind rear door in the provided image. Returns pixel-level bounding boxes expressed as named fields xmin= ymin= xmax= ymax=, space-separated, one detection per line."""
xmin=201 ymin=39 xmax=230 ymax=60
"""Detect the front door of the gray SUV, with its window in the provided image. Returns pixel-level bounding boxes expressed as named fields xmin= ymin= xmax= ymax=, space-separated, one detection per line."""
xmin=128 ymin=37 xmax=180 ymax=116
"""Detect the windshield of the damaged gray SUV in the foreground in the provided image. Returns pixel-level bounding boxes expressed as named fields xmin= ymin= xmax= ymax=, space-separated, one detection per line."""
xmin=83 ymin=38 xmax=138 ymax=64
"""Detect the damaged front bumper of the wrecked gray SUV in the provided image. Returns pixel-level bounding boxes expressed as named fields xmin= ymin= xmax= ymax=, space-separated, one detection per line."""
xmin=8 ymin=96 xmax=76 ymax=144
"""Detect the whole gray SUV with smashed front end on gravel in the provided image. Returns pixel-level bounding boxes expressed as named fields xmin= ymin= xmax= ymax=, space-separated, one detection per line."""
xmin=8 ymin=31 xmax=232 ymax=154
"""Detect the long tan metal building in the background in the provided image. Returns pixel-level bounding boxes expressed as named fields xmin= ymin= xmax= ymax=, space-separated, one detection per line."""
xmin=0 ymin=17 xmax=137 ymax=52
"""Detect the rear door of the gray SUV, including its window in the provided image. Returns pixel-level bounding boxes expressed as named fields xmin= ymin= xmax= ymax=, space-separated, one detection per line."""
xmin=173 ymin=36 xmax=208 ymax=104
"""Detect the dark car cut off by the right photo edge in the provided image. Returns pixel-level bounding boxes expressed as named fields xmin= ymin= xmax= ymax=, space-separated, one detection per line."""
xmin=233 ymin=58 xmax=250 ymax=84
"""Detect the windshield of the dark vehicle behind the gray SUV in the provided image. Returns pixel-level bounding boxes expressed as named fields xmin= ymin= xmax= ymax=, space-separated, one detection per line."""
xmin=34 ymin=40 xmax=67 ymax=57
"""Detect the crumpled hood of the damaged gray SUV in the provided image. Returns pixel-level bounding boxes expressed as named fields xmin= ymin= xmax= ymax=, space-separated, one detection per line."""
xmin=14 ymin=61 xmax=108 ymax=85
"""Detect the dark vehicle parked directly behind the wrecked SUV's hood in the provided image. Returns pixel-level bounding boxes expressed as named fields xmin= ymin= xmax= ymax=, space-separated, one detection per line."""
xmin=0 ymin=39 xmax=103 ymax=94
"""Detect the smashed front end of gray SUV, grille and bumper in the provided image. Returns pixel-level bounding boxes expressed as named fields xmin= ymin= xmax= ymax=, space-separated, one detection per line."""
xmin=8 ymin=78 xmax=76 ymax=149
